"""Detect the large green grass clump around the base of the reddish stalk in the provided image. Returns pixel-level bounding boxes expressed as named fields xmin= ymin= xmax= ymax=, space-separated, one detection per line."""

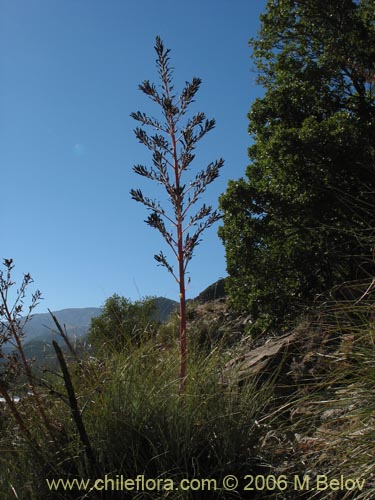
xmin=77 ymin=343 xmax=273 ymax=499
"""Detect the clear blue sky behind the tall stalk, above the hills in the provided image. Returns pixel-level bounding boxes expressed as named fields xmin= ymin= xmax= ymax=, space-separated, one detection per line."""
xmin=0 ymin=0 xmax=266 ymax=312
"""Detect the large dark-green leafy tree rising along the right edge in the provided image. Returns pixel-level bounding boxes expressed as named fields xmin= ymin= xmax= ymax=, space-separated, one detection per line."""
xmin=219 ymin=0 xmax=375 ymax=332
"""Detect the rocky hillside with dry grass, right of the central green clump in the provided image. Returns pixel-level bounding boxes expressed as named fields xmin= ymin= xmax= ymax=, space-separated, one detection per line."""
xmin=189 ymin=296 xmax=375 ymax=500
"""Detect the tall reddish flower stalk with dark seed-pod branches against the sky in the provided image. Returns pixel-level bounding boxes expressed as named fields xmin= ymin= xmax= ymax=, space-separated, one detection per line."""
xmin=130 ymin=37 xmax=224 ymax=392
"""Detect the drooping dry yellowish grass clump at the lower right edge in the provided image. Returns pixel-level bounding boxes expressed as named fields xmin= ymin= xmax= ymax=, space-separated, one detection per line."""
xmin=272 ymin=280 xmax=375 ymax=500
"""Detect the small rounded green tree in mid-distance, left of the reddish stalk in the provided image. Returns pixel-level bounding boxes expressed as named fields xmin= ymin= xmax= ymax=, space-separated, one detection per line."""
xmin=88 ymin=294 xmax=159 ymax=351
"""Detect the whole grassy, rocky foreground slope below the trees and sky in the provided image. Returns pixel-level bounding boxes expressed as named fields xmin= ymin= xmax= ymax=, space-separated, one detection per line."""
xmin=0 ymin=268 xmax=375 ymax=500
